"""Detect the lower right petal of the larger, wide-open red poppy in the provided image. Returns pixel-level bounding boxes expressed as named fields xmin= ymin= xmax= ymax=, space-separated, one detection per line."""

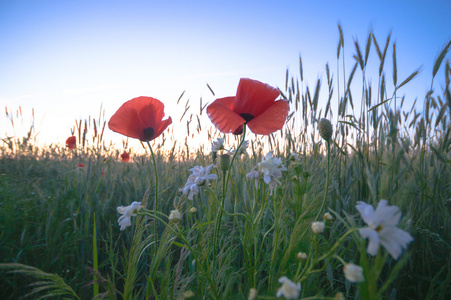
xmin=247 ymin=100 xmax=289 ymax=135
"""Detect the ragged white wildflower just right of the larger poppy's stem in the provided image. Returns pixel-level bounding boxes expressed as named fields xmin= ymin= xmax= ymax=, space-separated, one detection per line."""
xmin=246 ymin=152 xmax=287 ymax=194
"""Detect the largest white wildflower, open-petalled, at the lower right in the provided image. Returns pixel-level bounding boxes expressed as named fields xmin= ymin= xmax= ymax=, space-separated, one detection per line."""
xmin=356 ymin=200 xmax=413 ymax=259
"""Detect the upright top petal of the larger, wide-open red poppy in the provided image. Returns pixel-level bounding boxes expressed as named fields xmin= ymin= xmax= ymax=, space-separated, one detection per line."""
xmin=233 ymin=78 xmax=280 ymax=118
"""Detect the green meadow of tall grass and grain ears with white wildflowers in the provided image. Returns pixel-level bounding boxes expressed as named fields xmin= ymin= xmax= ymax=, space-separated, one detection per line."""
xmin=0 ymin=27 xmax=451 ymax=299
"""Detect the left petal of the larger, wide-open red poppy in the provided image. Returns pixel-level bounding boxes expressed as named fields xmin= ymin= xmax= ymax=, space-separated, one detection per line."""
xmin=207 ymin=97 xmax=246 ymax=133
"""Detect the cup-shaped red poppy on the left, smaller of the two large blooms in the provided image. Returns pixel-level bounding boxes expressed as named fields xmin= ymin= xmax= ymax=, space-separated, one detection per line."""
xmin=108 ymin=97 xmax=172 ymax=142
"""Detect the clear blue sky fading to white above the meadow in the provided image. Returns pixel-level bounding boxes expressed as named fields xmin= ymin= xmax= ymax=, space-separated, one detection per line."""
xmin=0 ymin=0 xmax=451 ymax=143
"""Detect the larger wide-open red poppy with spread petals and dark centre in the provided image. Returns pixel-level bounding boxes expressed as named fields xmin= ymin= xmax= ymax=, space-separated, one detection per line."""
xmin=207 ymin=78 xmax=289 ymax=135
